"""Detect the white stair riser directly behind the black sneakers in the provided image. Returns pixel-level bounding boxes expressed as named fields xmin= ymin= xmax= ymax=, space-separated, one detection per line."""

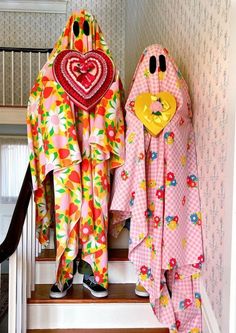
xmin=36 ymin=261 xmax=137 ymax=284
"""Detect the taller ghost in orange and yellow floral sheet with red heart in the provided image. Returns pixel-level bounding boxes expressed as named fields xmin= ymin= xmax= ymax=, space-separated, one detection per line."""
xmin=27 ymin=10 xmax=124 ymax=290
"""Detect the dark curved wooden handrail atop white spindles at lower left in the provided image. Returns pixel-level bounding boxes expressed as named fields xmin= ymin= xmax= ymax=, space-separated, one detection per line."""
xmin=0 ymin=165 xmax=32 ymax=263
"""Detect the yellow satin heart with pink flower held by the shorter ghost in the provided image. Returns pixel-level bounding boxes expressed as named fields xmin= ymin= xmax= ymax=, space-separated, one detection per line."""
xmin=134 ymin=91 xmax=176 ymax=136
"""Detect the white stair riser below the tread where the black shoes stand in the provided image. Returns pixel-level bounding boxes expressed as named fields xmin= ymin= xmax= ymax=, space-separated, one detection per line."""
xmin=28 ymin=303 xmax=167 ymax=329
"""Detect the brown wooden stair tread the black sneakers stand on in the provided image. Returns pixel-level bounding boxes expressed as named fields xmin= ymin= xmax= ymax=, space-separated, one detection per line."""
xmin=27 ymin=283 xmax=149 ymax=304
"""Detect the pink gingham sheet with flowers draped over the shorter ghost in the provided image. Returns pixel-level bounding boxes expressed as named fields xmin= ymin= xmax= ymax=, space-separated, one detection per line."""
xmin=110 ymin=45 xmax=203 ymax=333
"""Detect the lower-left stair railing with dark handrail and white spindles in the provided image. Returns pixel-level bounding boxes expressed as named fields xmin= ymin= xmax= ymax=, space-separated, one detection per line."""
xmin=0 ymin=166 xmax=37 ymax=333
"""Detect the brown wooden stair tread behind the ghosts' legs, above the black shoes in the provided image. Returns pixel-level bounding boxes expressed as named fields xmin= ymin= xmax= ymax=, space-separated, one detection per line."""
xmin=36 ymin=249 xmax=128 ymax=261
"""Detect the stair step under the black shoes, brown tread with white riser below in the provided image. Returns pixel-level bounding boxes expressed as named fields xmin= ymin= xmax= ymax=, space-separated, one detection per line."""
xmin=27 ymin=284 xmax=168 ymax=333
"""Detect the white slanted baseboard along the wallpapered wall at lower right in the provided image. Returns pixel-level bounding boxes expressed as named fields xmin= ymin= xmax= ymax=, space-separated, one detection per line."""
xmin=201 ymin=281 xmax=221 ymax=333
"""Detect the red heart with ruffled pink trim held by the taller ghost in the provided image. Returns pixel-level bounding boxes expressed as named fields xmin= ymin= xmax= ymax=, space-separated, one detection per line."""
xmin=53 ymin=50 xmax=115 ymax=110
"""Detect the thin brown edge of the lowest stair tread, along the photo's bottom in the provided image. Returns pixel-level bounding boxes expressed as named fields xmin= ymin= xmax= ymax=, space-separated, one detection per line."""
xmin=27 ymin=328 xmax=169 ymax=333
